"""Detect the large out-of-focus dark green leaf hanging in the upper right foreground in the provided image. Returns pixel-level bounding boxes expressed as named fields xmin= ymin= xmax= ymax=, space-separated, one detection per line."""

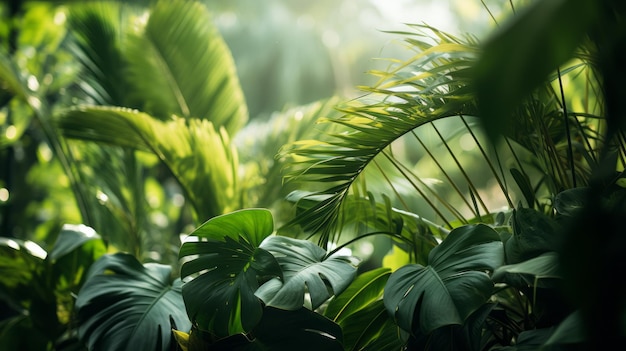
xmin=474 ymin=0 xmax=599 ymax=139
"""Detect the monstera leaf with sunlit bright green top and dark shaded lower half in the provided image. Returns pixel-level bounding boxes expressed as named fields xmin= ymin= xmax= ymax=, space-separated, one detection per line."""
xmin=180 ymin=209 xmax=280 ymax=337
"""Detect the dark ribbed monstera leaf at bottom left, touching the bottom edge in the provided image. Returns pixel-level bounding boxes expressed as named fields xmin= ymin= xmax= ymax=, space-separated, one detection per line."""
xmin=76 ymin=253 xmax=191 ymax=351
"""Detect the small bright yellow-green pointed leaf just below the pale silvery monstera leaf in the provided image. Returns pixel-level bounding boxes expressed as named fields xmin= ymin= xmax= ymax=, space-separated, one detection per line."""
xmin=324 ymin=268 xmax=391 ymax=324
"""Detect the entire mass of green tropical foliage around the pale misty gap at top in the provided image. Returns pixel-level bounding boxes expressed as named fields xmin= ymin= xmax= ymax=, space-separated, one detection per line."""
xmin=0 ymin=0 xmax=626 ymax=351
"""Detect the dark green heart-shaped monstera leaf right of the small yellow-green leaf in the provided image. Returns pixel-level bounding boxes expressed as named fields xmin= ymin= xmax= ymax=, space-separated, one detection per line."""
xmin=384 ymin=224 xmax=503 ymax=334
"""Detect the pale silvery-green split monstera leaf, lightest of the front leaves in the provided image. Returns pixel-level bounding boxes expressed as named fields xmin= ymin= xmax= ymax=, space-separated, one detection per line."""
xmin=256 ymin=236 xmax=357 ymax=310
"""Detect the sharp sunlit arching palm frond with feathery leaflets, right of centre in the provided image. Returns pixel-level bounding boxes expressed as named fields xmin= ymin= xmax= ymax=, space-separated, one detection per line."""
xmin=282 ymin=26 xmax=486 ymax=250
